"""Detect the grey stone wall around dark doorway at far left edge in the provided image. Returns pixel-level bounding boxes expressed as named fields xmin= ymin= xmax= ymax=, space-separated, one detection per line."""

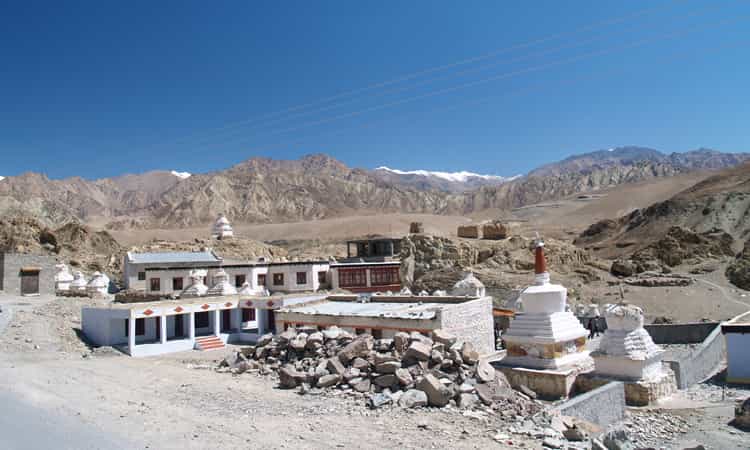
xmin=0 ymin=253 xmax=57 ymax=295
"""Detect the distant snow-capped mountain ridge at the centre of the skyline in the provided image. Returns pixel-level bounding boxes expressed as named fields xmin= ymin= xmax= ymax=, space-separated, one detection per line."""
xmin=373 ymin=166 xmax=518 ymax=193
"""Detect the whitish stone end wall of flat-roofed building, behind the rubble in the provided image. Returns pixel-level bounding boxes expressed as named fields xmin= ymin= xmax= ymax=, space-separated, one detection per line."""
xmin=440 ymin=297 xmax=495 ymax=355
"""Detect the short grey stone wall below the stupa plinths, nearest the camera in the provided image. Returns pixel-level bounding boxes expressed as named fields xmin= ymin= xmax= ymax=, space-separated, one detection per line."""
xmin=555 ymin=381 xmax=625 ymax=427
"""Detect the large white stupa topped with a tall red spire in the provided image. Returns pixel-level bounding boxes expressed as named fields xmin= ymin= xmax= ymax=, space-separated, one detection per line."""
xmin=502 ymin=241 xmax=593 ymax=370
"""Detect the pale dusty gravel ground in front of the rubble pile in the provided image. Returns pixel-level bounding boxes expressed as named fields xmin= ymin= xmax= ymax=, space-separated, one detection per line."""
xmin=0 ymin=297 xmax=540 ymax=449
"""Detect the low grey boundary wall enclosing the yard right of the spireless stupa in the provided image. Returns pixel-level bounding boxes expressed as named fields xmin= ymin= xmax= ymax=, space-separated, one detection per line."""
xmin=645 ymin=322 xmax=726 ymax=389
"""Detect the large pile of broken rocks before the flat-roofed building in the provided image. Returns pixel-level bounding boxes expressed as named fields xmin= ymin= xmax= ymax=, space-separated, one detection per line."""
xmin=220 ymin=327 xmax=541 ymax=417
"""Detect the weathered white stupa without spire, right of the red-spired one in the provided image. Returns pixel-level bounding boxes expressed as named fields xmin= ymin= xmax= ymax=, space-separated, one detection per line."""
xmin=592 ymin=303 xmax=664 ymax=380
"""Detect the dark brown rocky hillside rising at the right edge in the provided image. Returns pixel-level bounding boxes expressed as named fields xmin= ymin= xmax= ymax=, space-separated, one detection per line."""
xmin=575 ymin=163 xmax=750 ymax=289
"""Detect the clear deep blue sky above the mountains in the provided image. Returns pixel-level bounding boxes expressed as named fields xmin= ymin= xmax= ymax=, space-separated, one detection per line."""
xmin=0 ymin=0 xmax=750 ymax=178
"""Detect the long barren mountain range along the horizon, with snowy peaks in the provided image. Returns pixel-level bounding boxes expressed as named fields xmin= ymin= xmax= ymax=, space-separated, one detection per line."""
xmin=0 ymin=147 xmax=750 ymax=228
